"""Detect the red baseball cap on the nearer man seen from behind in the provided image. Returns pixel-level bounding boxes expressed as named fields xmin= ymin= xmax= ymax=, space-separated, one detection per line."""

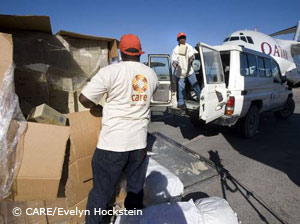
xmin=120 ymin=34 xmax=145 ymax=56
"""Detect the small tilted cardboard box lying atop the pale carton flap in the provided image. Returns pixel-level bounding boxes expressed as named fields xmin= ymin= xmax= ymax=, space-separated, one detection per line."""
xmin=27 ymin=104 xmax=67 ymax=126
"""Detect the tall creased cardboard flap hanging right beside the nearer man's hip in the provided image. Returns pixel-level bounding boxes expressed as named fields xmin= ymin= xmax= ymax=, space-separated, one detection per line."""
xmin=66 ymin=111 xmax=101 ymax=207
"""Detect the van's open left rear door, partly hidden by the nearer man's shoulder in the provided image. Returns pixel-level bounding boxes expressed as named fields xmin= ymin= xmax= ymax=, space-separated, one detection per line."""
xmin=148 ymin=54 xmax=172 ymax=106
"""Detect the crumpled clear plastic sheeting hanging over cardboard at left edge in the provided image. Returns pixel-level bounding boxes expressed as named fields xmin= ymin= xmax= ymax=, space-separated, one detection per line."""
xmin=0 ymin=65 xmax=26 ymax=200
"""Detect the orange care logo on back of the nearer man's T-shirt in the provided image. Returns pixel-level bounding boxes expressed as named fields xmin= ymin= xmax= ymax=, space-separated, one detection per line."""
xmin=131 ymin=74 xmax=148 ymax=102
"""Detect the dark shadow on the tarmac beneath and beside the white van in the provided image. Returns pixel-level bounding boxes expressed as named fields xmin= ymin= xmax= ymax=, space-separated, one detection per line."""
xmin=152 ymin=108 xmax=300 ymax=186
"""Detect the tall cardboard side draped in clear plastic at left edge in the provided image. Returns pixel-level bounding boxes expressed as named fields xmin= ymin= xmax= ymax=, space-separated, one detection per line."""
xmin=0 ymin=31 xmax=26 ymax=199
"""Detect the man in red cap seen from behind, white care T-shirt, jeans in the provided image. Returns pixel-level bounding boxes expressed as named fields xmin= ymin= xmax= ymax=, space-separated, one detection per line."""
xmin=79 ymin=34 xmax=158 ymax=224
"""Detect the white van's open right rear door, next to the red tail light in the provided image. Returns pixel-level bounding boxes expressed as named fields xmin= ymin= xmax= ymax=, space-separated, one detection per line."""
xmin=196 ymin=43 xmax=227 ymax=123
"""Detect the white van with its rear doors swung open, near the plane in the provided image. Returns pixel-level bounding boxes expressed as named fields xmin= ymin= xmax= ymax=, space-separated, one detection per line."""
xmin=148 ymin=43 xmax=295 ymax=138
